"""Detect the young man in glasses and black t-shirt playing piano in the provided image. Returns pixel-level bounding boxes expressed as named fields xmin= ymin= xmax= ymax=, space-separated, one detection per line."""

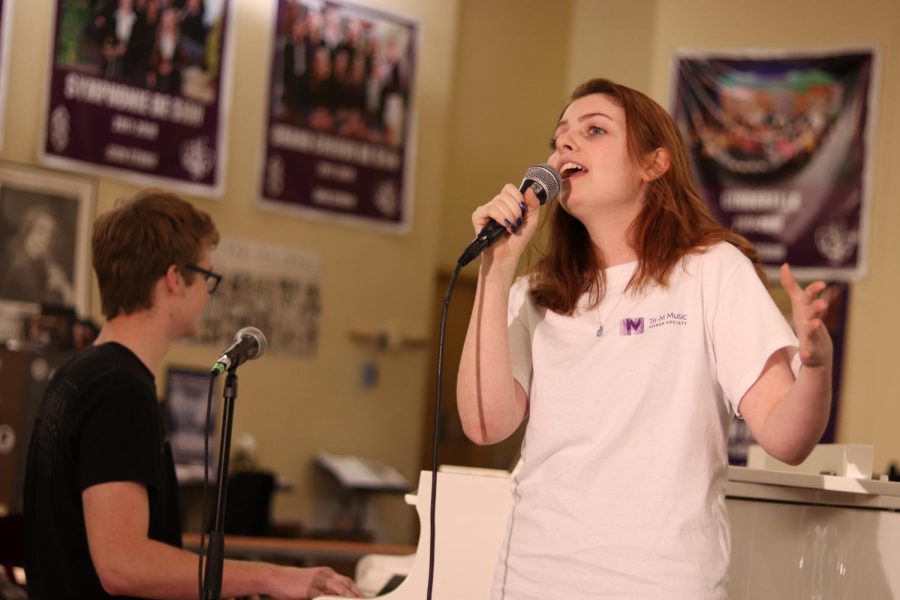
xmin=25 ymin=190 xmax=359 ymax=600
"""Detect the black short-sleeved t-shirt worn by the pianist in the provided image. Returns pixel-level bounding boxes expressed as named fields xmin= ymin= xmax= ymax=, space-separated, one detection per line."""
xmin=24 ymin=343 xmax=181 ymax=600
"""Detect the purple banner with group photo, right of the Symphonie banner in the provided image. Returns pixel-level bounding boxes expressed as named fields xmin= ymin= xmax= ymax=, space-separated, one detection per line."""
xmin=260 ymin=0 xmax=418 ymax=233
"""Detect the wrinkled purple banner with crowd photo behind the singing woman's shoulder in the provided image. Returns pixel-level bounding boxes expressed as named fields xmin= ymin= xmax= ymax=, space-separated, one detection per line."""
xmin=672 ymin=49 xmax=876 ymax=281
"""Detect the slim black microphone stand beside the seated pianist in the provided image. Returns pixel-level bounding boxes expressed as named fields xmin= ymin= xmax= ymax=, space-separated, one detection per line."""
xmin=201 ymin=366 xmax=237 ymax=600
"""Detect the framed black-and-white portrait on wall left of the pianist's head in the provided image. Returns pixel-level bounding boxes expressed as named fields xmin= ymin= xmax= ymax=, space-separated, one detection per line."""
xmin=0 ymin=163 xmax=95 ymax=339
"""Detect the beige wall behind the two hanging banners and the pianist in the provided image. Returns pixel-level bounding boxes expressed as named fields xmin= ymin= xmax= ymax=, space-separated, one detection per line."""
xmin=0 ymin=0 xmax=458 ymax=541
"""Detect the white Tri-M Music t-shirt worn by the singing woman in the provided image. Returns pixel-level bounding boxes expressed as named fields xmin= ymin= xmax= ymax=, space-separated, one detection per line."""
xmin=492 ymin=243 xmax=797 ymax=600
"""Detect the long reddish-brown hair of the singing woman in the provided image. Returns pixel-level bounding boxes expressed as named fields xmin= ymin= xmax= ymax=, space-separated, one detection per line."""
xmin=529 ymin=79 xmax=763 ymax=315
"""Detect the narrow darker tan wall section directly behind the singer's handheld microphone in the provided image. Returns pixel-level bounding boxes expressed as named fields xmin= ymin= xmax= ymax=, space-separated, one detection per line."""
xmin=438 ymin=0 xmax=570 ymax=270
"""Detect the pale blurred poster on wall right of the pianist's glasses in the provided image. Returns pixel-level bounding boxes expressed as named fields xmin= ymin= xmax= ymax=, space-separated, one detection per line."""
xmin=189 ymin=239 xmax=322 ymax=356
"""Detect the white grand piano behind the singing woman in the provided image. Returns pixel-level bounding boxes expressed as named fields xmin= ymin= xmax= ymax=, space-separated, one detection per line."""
xmin=323 ymin=449 xmax=900 ymax=600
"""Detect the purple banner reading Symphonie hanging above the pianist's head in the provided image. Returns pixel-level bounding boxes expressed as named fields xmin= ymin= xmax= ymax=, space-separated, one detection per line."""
xmin=38 ymin=0 xmax=232 ymax=196
